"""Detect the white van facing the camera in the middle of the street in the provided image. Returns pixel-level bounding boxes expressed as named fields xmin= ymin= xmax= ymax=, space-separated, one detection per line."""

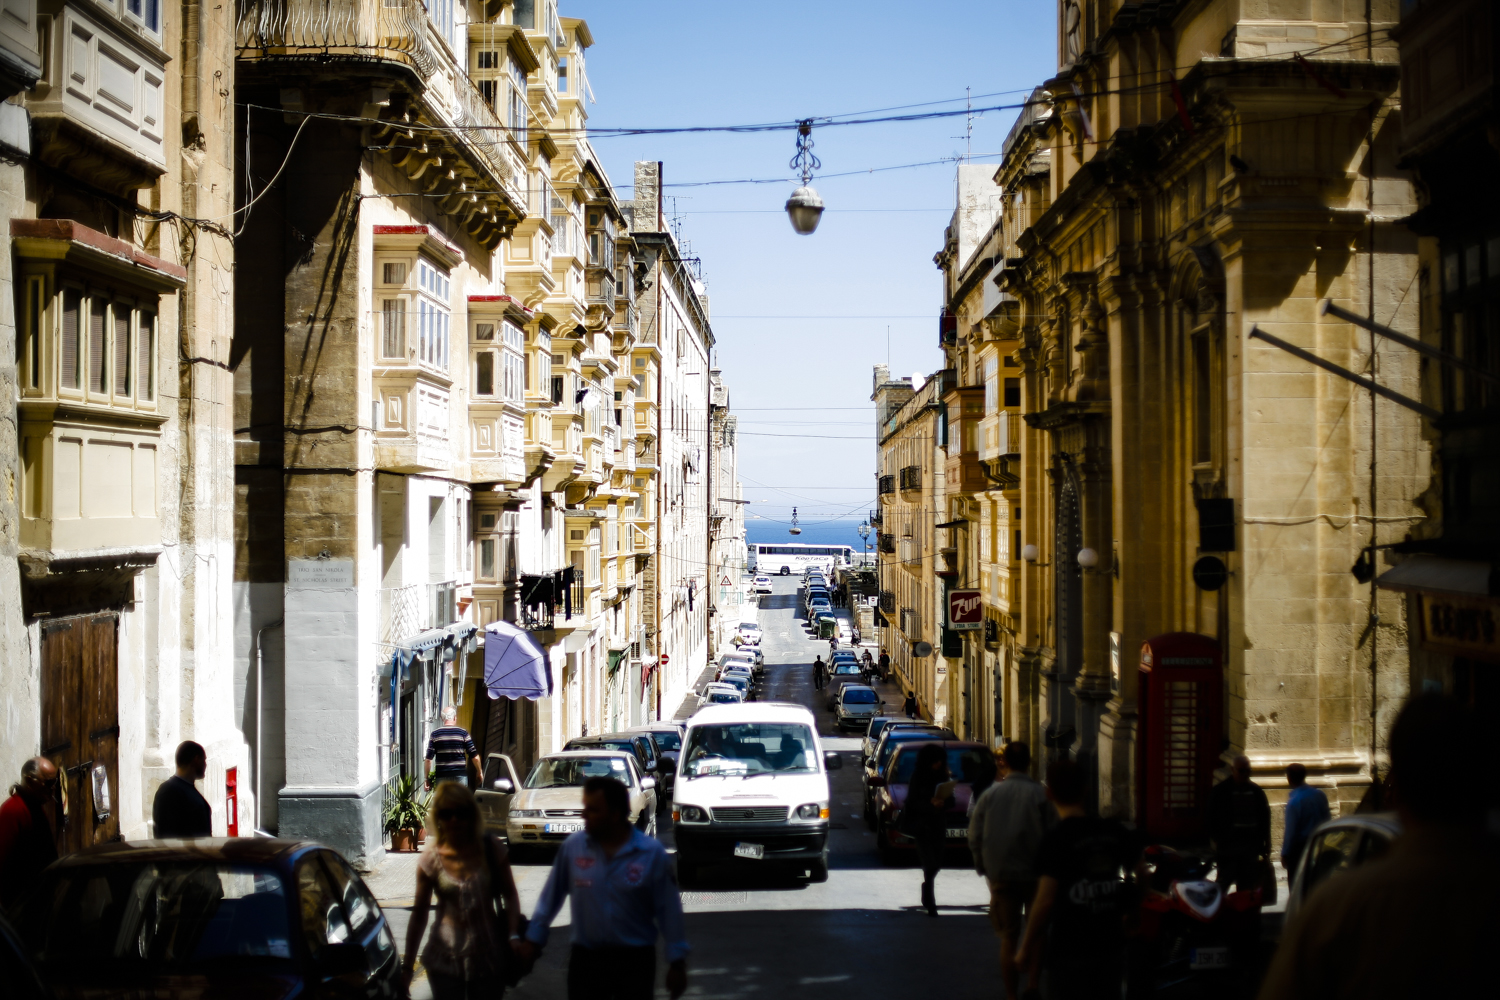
xmin=672 ymin=702 xmax=843 ymax=883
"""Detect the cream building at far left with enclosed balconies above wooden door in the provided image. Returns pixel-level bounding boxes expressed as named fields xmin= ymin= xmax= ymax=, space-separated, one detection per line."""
xmin=0 ymin=0 xmax=243 ymax=849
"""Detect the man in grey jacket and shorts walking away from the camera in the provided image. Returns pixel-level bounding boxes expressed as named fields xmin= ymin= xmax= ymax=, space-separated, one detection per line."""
xmin=969 ymin=739 xmax=1058 ymax=997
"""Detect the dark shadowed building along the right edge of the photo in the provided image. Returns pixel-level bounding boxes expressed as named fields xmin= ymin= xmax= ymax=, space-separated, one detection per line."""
xmin=1371 ymin=0 xmax=1500 ymax=802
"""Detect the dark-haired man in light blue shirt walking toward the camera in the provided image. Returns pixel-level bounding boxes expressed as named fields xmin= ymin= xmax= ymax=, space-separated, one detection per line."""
xmin=522 ymin=777 xmax=689 ymax=1000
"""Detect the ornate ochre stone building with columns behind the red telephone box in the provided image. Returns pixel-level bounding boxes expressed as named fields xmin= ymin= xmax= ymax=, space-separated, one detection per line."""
xmin=938 ymin=0 xmax=1430 ymax=839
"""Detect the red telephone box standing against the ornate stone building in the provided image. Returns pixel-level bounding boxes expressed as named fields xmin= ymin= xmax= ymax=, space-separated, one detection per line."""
xmin=1136 ymin=633 xmax=1224 ymax=841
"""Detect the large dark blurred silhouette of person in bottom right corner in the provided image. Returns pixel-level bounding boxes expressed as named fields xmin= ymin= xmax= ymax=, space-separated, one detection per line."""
xmin=1260 ymin=694 xmax=1500 ymax=1000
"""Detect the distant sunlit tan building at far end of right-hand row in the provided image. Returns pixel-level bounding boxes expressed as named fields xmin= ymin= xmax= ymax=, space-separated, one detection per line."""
xmin=870 ymin=364 xmax=962 ymax=724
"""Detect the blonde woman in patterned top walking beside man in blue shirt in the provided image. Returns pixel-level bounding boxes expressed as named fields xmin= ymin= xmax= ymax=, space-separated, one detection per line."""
xmin=402 ymin=781 xmax=522 ymax=1000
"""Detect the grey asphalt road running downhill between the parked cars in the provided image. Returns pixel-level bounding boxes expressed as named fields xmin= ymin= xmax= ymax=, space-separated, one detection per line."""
xmin=386 ymin=577 xmax=1001 ymax=1000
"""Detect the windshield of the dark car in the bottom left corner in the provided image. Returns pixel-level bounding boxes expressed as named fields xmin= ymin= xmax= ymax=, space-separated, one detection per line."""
xmin=14 ymin=861 xmax=293 ymax=973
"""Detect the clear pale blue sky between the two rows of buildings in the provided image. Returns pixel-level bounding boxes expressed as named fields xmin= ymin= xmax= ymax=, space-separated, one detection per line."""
xmin=560 ymin=0 xmax=1056 ymax=544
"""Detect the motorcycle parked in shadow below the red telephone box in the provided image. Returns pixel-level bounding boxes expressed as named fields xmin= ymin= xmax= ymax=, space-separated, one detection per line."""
xmin=1128 ymin=844 xmax=1262 ymax=1000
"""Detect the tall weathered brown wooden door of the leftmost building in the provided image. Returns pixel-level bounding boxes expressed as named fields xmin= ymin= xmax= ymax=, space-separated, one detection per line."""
xmin=42 ymin=613 xmax=120 ymax=853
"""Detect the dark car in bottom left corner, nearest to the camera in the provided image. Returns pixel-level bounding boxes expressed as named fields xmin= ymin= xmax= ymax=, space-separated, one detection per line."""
xmin=5 ymin=837 xmax=407 ymax=1000
